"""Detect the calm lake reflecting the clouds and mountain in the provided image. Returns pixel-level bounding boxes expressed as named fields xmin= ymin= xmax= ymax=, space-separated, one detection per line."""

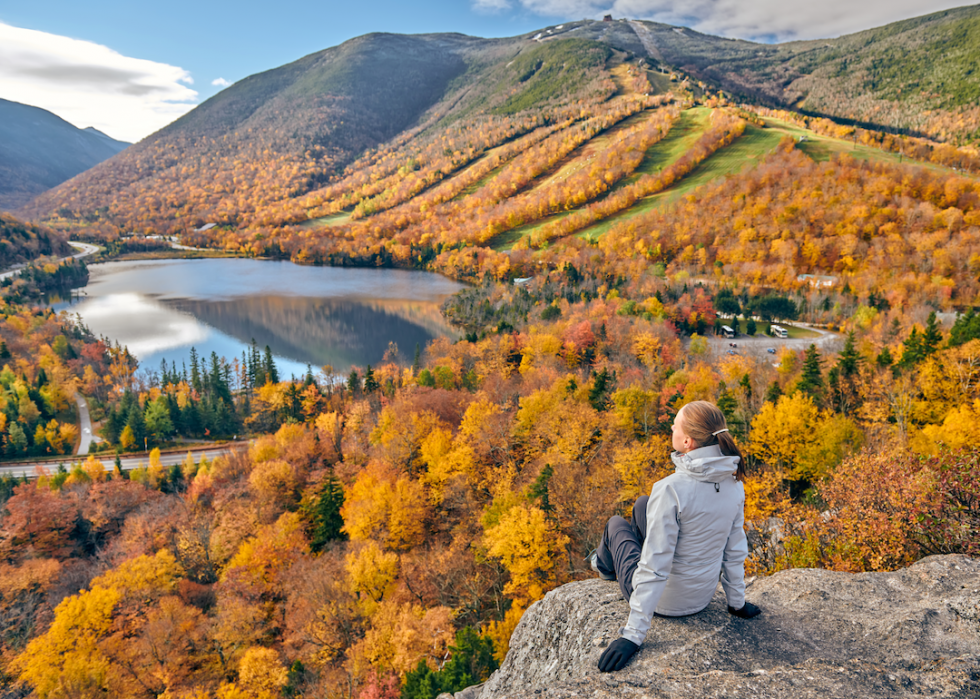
xmin=52 ymin=259 xmax=463 ymax=377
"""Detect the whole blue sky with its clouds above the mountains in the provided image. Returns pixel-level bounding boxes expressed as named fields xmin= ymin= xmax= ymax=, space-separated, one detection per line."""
xmin=0 ymin=0 xmax=961 ymax=141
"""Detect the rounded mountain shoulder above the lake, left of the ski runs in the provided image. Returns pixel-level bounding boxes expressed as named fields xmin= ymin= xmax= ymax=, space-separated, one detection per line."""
xmin=25 ymin=34 xmax=609 ymax=232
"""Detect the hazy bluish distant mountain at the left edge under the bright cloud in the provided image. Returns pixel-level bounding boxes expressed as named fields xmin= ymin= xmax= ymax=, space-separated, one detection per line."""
xmin=0 ymin=99 xmax=129 ymax=210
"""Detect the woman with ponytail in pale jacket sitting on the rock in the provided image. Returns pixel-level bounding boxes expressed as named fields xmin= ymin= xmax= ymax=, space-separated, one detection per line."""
xmin=591 ymin=401 xmax=760 ymax=672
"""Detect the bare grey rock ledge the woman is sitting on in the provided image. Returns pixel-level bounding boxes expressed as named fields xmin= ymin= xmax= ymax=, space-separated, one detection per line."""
xmin=480 ymin=556 xmax=980 ymax=699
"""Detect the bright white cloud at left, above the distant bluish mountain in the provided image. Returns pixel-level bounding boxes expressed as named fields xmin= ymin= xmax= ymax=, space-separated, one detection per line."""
xmin=0 ymin=23 xmax=198 ymax=141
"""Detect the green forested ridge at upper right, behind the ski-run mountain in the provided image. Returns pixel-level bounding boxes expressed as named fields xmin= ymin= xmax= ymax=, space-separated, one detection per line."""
xmin=620 ymin=5 xmax=980 ymax=142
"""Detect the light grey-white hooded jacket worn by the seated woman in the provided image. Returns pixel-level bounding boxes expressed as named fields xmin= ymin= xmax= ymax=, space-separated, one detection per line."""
xmin=620 ymin=445 xmax=748 ymax=645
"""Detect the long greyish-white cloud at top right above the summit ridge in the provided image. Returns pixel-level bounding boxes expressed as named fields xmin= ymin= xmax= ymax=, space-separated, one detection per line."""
xmin=494 ymin=0 xmax=963 ymax=41
